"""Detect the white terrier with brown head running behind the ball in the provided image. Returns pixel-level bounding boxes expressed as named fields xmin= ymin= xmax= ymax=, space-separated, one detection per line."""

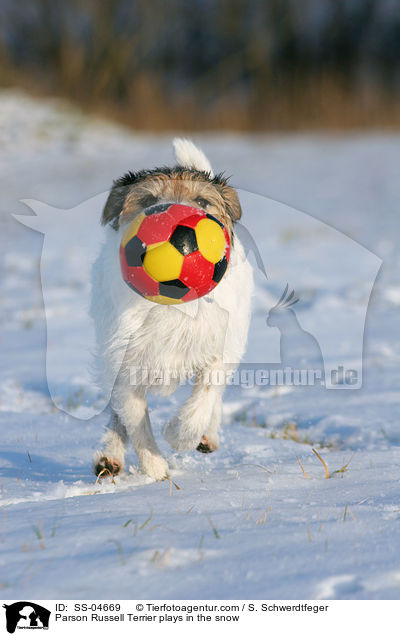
xmin=91 ymin=139 xmax=252 ymax=479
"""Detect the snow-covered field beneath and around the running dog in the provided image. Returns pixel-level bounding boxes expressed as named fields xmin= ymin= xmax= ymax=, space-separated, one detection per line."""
xmin=0 ymin=92 xmax=400 ymax=599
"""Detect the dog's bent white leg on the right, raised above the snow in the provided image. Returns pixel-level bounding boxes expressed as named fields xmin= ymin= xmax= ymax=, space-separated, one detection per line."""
xmin=165 ymin=364 xmax=225 ymax=452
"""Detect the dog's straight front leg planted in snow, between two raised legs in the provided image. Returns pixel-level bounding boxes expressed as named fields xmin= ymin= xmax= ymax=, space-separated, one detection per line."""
xmin=112 ymin=387 xmax=168 ymax=480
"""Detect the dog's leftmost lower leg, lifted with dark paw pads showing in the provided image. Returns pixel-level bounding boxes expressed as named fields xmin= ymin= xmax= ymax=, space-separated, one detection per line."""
xmin=93 ymin=413 xmax=128 ymax=477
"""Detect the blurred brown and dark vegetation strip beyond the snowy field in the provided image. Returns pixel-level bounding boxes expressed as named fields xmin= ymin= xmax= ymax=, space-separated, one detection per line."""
xmin=0 ymin=0 xmax=400 ymax=131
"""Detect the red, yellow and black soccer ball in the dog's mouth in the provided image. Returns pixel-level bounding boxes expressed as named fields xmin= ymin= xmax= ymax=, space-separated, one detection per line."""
xmin=120 ymin=203 xmax=230 ymax=305
